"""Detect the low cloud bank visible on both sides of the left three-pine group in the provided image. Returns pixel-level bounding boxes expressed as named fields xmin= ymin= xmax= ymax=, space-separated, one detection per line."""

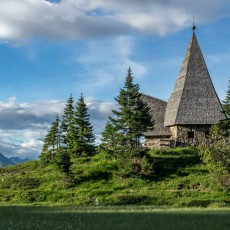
xmin=0 ymin=97 xmax=114 ymax=158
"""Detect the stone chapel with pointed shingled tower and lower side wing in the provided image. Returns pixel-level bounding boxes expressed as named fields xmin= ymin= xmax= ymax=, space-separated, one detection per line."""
xmin=143 ymin=25 xmax=226 ymax=148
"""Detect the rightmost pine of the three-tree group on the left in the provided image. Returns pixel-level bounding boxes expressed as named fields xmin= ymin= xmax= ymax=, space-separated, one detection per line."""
xmin=69 ymin=94 xmax=95 ymax=155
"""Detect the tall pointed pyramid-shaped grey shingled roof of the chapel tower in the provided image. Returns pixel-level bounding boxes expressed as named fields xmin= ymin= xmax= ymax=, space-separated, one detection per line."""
xmin=164 ymin=31 xmax=225 ymax=126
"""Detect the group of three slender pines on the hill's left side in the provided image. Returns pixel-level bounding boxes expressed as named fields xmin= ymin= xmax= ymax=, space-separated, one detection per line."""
xmin=40 ymin=94 xmax=95 ymax=174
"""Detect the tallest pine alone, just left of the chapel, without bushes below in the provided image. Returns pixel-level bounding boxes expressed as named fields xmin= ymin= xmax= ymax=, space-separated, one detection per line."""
xmin=109 ymin=68 xmax=154 ymax=152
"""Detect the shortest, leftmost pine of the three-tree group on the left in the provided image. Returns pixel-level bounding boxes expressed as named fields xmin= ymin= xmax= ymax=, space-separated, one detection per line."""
xmin=40 ymin=115 xmax=60 ymax=162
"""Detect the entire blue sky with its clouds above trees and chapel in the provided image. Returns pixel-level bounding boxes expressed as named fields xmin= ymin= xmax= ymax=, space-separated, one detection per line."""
xmin=0 ymin=0 xmax=230 ymax=158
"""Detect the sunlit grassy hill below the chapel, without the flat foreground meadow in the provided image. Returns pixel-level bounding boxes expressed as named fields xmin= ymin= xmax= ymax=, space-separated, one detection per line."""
xmin=0 ymin=148 xmax=230 ymax=207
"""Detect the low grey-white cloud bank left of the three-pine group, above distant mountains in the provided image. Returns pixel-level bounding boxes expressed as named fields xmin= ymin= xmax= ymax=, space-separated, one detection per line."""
xmin=0 ymin=97 xmax=65 ymax=158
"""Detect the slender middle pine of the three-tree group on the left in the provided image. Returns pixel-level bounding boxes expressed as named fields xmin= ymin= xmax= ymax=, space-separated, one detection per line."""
xmin=61 ymin=94 xmax=74 ymax=146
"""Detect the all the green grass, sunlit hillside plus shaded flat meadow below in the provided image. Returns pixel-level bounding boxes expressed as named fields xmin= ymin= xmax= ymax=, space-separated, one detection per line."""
xmin=0 ymin=148 xmax=230 ymax=230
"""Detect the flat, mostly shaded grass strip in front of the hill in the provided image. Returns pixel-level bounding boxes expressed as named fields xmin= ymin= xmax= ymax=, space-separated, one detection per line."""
xmin=0 ymin=206 xmax=230 ymax=230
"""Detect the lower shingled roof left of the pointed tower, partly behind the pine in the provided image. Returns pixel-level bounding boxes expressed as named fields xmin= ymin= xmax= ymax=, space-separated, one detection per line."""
xmin=142 ymin=94 xmax=171 ymax=136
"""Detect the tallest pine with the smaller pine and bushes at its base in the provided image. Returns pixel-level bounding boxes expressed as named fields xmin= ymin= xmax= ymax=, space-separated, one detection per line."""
xmin=101 ymin=68 xmax=154 ymax=177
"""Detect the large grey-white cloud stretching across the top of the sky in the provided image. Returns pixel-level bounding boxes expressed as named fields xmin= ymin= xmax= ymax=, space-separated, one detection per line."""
xmin=0 ymin=0 xmax=230 ymax=40
